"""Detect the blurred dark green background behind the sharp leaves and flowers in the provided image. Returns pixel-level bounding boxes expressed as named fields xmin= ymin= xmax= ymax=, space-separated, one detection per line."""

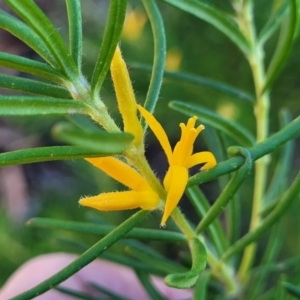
xmin=0 ymin=0 xmax=300 ymax=286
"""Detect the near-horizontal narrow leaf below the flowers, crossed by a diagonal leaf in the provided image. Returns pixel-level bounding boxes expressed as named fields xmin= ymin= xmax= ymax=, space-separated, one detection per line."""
xmin=26 ymin=218 xmax=186 ymax=242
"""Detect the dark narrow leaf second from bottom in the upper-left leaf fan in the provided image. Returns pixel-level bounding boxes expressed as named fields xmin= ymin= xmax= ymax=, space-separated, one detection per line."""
xmin=0 ymin=74 xmax=71 ymax=99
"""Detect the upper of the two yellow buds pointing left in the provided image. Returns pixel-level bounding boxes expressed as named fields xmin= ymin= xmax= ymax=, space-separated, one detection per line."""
xmin=85 ymin=156 xmax=151 ymax=191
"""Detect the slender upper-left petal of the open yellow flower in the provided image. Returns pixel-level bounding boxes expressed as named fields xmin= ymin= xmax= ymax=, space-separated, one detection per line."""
xmin=138 ymin=105 xmax=172 ymax=164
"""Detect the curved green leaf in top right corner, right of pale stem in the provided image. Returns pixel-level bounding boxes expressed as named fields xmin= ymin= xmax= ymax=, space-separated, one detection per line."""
xmin=263 ymin=0 xmax=300 ymax=91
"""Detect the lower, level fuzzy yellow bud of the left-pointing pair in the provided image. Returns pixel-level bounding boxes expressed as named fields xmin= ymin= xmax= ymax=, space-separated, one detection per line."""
xmin=79 ymin=191 xmax=159 ymax=211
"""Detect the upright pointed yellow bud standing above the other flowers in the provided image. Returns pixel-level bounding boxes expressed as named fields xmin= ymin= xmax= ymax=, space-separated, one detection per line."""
xmin=110 ymin=46 xmax=144 ymax=145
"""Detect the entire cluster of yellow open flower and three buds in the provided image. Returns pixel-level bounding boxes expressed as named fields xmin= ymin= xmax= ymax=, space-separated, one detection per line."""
xmin=79 ymin=47 xmax=216 ymax=226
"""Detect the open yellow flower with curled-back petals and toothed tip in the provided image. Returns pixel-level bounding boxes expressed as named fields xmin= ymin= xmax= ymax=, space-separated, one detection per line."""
xmin=138 ymin=105 xmax=217 ymax=226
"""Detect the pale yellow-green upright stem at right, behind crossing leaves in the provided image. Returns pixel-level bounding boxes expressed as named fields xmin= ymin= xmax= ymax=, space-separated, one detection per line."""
xmin=238 ymin=2 xmax=269 ymax=281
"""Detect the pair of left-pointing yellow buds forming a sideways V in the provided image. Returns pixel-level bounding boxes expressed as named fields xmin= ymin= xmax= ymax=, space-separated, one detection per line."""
xmin=79 ymin=156 xmax=159 ymax=211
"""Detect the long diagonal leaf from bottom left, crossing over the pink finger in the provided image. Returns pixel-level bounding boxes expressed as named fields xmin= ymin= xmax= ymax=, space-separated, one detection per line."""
xmin=12 ymin=210 xmax=149 ymax=300
